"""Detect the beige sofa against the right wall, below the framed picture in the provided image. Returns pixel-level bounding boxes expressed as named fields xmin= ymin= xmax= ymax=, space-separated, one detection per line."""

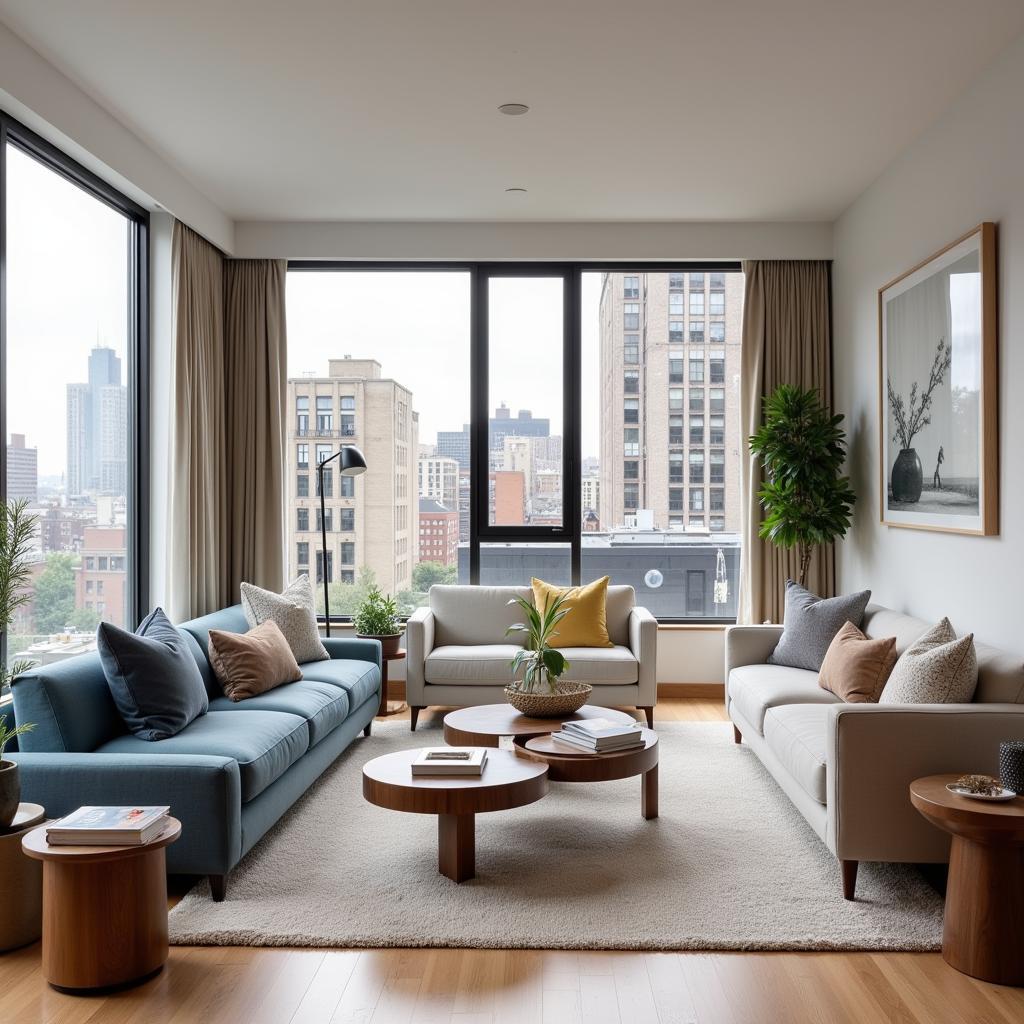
xmin=725 ymin=605 xmax=1024 ymax=899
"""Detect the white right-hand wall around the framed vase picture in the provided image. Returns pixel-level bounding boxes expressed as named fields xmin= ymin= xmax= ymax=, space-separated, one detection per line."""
xmin=834 ymin=39 xmax=1024 ymax=650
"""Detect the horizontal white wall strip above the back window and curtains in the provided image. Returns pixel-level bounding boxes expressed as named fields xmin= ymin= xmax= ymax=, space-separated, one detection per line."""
xmin=234 ymin=221 xmax=833 ymax=261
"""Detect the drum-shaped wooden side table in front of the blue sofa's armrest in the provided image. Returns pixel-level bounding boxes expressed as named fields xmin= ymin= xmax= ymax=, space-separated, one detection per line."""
xmin=22 ymin=818 xmax=181 ymax=991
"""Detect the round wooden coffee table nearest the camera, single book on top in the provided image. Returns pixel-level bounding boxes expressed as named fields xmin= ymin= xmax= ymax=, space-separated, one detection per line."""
xmin=362 ymin=750 xmax=548 ymax=882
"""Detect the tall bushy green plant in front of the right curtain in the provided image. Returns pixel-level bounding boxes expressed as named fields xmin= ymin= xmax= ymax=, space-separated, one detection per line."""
xmin=750 ymin=384 xmax=856 ymax=587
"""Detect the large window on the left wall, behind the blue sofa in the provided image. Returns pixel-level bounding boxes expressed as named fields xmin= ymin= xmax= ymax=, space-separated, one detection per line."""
xmin=0 ymin=116 xmax=147 ymax=684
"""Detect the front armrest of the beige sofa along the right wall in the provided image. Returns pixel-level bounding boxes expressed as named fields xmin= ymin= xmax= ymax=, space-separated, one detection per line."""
xmin=825 ymin=703 xmax=1024 ymax=862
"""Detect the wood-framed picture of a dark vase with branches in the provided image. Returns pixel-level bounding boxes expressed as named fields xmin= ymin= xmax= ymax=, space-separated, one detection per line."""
xmin=879 ymin=222 xmax=999 ymax=537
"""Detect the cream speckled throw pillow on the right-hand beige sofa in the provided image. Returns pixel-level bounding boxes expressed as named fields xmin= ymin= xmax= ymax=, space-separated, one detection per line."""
xmin=879 ymin=618 xmax=978 ymax=703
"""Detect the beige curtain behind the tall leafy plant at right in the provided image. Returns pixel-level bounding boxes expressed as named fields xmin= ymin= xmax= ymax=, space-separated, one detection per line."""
xmin=737 ymin=260 xmax=836 ymax=623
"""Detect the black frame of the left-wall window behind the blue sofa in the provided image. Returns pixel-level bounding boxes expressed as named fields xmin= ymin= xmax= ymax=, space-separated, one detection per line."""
xmin=0 ymin=110 xmax=151 ymax=658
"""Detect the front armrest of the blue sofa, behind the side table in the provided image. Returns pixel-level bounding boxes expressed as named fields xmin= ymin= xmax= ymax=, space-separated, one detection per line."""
xmin=11 ymin=753 xmax=242 ymax=874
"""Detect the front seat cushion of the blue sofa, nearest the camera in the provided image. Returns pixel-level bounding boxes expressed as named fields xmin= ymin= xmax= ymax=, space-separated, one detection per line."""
xmin=97 ymin=711 xmax=309 ymax=803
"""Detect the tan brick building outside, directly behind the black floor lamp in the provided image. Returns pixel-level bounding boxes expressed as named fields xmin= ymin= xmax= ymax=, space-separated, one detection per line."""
xmin=287 ymin=356 xmax=419 ymax=594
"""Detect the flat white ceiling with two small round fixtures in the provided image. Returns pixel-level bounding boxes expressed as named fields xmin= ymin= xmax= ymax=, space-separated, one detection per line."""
xmin=0 ymin=0 xmax=1024 ymax=220
